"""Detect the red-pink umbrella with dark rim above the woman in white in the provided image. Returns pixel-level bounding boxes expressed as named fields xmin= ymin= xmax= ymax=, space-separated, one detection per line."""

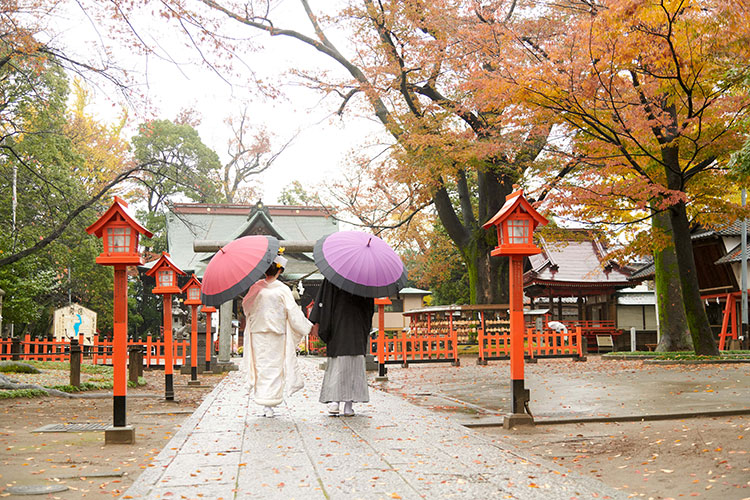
xmin=201 ymin=235 xmax=279 ymax=306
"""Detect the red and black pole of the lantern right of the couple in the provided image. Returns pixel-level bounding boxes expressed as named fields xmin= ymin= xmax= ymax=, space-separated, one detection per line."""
xmin=510 ymin=255 xmax=529 ymax=413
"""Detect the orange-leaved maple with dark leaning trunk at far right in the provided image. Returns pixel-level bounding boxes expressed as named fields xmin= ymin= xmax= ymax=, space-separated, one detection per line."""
xmin=494 ymin=0 xmax=750 ymax=354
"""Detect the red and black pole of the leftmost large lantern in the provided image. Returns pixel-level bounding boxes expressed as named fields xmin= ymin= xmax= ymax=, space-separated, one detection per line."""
xmin=112 ymin=265 xmax=128 ymax=427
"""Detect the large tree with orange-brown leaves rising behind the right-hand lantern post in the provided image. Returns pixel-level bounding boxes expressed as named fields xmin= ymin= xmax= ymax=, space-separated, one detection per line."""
xmin=94 ymin=0 xmax=550 ymax=302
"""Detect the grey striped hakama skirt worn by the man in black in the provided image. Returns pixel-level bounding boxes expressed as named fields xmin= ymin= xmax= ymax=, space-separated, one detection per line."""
xmin=320 ymin=355 xmax=370 ymax=403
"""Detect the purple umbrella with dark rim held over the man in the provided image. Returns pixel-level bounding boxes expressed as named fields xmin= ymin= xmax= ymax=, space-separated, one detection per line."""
xmin=313 ymin=231 xmax=406 ymax=297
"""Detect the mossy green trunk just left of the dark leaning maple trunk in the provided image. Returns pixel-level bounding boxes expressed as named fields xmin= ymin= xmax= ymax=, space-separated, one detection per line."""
xmin=651 ymin=212 xmax=693 ymax=352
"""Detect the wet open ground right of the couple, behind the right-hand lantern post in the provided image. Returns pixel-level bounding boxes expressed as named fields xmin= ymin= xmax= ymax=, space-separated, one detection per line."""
xmin=375 ymin=356 xmax=750 ymax=426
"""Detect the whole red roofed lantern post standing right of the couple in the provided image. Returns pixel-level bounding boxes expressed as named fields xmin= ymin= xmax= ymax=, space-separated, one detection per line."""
xmin=482 ymin=190 xmax=547 ymax=428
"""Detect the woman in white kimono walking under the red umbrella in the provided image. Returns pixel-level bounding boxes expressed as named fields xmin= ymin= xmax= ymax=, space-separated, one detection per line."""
xmin=242 ymin=255 xmax=312 ymax=417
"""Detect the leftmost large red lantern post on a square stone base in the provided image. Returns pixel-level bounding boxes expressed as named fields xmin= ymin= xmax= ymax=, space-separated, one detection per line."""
xmin=86 ymin=196 xmax=153 ymax=443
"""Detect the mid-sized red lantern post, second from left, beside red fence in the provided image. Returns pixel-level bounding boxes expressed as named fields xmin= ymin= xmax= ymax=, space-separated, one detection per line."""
xmin=146 ymin=252 xmax=185 ymax=401
